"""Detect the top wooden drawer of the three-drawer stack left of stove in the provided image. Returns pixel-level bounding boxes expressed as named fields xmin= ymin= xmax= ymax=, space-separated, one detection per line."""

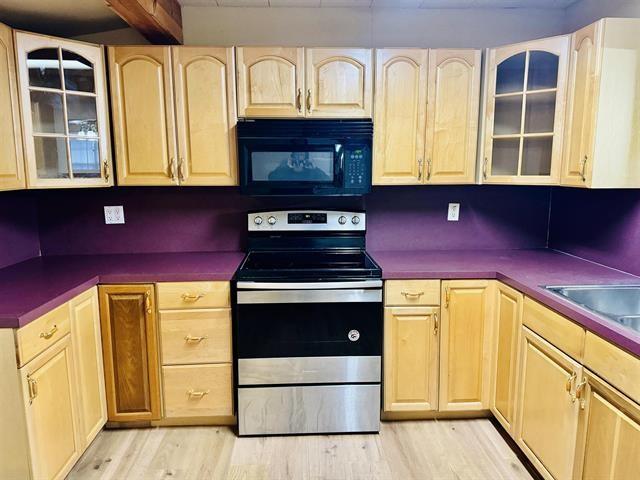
xmin=157 ymin=282 xmax=230 ymax=310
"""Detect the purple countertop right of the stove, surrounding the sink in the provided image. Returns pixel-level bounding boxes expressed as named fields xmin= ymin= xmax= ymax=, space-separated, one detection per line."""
xmin=369 ymin=250 xmax=640 ymax=356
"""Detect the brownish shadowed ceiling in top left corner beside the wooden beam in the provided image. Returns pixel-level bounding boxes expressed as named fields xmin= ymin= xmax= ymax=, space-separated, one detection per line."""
xmin=0 ymin=0 xmax=127 ymax=37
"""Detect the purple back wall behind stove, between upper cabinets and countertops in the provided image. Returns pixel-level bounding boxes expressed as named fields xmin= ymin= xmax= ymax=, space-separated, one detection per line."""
xmin=38 ymin=186 xmax=550 ymax=255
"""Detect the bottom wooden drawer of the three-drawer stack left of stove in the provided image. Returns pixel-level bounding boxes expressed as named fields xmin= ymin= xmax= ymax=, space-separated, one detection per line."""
xmin=162 ymin=363 xmax=233 ymax=418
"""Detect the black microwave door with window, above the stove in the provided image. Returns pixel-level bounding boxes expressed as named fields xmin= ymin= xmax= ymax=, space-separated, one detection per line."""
xmin=238 ymin=138 xmax=344 ymax=195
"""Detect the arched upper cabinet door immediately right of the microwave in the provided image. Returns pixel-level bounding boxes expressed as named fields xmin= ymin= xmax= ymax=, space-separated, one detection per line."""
xmin=373 ymin=49 xmax=428 ymax=185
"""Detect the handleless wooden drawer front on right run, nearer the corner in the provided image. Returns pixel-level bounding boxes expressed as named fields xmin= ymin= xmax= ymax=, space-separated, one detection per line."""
xmin=522 ymin=297 xmax=586 ymax=361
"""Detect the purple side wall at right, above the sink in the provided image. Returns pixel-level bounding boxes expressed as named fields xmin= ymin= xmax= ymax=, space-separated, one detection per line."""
xmin=549 ymin=188 xmax=640 ymax=275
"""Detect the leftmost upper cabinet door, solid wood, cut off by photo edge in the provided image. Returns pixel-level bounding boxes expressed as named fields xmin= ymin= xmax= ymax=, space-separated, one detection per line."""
xmin=0 ymin=24 xmax=26 ymax=190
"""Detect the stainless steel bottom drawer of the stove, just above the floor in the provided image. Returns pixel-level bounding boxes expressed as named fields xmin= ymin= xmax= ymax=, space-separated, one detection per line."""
xmin=238 ymin=384 xmax=380 ymax=435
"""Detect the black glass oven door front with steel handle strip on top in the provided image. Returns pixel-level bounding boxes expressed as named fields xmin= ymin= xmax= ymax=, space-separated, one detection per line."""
xmin=236 ymin=281 xmax=382 ymax=359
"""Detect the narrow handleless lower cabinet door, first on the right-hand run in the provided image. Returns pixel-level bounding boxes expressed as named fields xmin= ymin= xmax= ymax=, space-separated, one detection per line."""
xmin=491 ymin=282 xmax=523 ymax=433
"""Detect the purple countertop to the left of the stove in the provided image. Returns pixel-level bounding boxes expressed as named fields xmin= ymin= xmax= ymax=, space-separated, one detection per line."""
xmin=0 ymin=252 xmax=244 ymax=328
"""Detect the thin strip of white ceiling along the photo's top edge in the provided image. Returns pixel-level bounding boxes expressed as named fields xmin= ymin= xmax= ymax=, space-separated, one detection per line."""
xmin=178 ymin=0 xmax=578 ymax=9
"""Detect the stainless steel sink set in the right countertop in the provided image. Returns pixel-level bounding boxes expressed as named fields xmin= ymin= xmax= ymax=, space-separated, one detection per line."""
xmin=545 ymin=285 xmax=640 ymax=333
